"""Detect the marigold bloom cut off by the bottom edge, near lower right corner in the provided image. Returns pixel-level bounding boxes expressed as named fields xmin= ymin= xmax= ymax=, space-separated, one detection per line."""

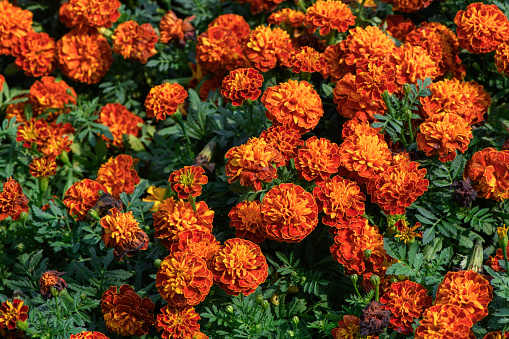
xmin=415 ymin=304 xmax=472 ymax=339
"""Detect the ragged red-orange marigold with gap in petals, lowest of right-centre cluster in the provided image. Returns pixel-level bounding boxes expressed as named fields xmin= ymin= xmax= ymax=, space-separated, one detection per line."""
xmin=330 ymin=218 xmax=385 ymax=275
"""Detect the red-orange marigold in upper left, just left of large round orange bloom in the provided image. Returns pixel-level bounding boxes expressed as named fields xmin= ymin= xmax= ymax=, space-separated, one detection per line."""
xmin=12 ymin=32 xmax=57 ymax=77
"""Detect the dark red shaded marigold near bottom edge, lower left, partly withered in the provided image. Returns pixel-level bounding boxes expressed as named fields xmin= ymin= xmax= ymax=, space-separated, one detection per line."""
xmin=101 ymin=284 xmax=155 ymax=336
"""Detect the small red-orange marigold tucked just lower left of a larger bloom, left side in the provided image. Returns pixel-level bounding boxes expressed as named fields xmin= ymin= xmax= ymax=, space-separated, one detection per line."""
xmin=63 ymin=179 xmax=107 ymax=220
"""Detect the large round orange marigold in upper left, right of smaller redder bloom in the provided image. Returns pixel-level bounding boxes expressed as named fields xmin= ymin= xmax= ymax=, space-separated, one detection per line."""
xmin=57 ymin=29 xmax=113 ymax=85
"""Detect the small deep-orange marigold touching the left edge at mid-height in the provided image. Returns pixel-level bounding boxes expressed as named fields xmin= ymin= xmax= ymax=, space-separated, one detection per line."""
xmin=0 ymin=178 xmax=28 ymax=221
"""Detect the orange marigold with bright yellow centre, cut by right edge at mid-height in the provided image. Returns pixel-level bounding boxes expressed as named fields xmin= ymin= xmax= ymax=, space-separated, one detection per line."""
xmin=463 ymin=147 xmax=509 ymax=201
